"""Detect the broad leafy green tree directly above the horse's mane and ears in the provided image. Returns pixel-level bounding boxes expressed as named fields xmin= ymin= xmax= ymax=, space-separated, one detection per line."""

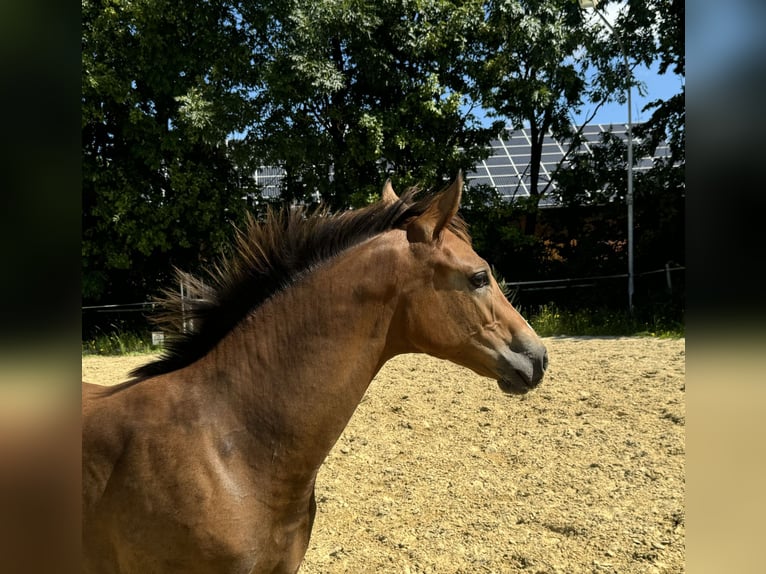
xmin=244 ymin=0 xmax=494 ymax=208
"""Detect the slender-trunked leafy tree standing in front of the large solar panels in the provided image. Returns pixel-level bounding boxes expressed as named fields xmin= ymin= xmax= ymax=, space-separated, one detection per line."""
xmin=474 ymin=0 xmax=587 ymax=235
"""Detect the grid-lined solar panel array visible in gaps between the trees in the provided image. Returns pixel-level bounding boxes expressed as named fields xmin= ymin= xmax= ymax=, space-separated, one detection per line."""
xmin=254 ymin=124 xmax=670 ymax=206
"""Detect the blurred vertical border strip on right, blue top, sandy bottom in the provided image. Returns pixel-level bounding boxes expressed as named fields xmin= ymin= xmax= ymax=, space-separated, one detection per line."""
xmin=686 ymin=0 xmax=766 ymax=574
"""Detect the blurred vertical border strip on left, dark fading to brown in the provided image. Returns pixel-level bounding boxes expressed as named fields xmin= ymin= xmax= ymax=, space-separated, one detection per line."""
xmin=0 ymin=0 xmax=81 ymax=574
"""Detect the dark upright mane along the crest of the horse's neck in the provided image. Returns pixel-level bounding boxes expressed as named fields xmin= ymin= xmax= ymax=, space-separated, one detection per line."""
xmin=130 ymin=189 xmax=470 ymax=383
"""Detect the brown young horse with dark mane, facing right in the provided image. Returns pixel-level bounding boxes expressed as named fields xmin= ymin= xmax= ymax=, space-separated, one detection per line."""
xmin=82 ymin=173 xmax=548 ymax=574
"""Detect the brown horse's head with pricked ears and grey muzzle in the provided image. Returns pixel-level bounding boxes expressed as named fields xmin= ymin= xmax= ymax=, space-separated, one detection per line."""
xmin=383 ymin=174 xmax=548 ymax=394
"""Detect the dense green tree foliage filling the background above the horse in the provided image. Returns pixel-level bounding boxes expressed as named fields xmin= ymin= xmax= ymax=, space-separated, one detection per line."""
xmin=82 ymin=0 xmax=684 ymax=308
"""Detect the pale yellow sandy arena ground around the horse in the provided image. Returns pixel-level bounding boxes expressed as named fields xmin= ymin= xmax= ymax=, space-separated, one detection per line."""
xmin=82 ymin=337 xmax=686 ymax=574
